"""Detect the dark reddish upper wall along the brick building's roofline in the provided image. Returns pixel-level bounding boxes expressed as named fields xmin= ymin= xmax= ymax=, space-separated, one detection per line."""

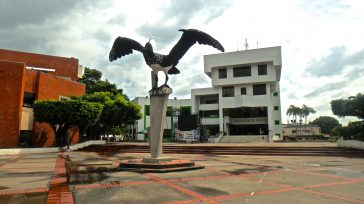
xmin=0 ymin=49 xmax=78 ymax=80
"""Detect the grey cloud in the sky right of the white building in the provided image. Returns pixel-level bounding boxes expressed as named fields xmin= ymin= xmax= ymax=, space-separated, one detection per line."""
xmin=306 ymin=46 xmax=364 ymax=77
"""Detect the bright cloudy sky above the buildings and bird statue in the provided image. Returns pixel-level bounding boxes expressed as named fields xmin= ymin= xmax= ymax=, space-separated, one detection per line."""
xmin=0 ymin=0 xmax=364 ymax=122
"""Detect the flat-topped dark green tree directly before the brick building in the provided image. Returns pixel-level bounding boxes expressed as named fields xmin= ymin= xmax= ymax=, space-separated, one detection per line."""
xmin=34 ymin=100 xmax=103 ymax=146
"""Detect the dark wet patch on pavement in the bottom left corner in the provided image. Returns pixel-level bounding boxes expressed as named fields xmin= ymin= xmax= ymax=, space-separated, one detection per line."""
xmin=0 ymin=193 xmax=48 ymax=204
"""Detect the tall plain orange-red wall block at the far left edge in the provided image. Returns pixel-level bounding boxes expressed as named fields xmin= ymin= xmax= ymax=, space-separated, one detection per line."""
xmin=0 ymin=61 xmax=25 ymax=147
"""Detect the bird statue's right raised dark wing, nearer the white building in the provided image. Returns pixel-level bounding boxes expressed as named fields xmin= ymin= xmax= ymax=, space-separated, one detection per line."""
xmin=161 ymin=29 xmax=225 ymax=66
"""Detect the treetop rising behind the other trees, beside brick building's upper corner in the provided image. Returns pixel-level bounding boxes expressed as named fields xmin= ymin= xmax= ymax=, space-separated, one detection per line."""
xmin=78 ymin=67 xmax=125 ymax=97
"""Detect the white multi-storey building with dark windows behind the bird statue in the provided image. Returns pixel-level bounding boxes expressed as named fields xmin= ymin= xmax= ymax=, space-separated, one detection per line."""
xmin=130 ymin=47 xmax=282 ymax=142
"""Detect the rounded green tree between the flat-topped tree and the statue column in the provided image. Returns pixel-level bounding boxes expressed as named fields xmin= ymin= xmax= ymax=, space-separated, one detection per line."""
xmin=74 ymin=92 xmax=141 ymax=139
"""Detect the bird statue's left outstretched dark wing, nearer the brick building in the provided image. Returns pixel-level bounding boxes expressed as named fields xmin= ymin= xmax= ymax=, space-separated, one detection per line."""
xmin=109 ymin=36 xmax=143 ymax=62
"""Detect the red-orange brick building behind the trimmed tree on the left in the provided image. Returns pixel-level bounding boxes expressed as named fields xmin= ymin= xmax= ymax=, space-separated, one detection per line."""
xmin=0 ymin=49 xmax=86 ymax=147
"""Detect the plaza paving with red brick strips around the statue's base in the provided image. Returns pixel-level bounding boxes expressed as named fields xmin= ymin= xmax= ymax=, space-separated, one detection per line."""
xmin=0 ymin=144 xmax=364 ymax=204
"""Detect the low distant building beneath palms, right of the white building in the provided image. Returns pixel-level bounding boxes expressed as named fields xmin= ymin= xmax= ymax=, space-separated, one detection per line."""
xmin=282 ymin=123 xmax=324 ymax=141
